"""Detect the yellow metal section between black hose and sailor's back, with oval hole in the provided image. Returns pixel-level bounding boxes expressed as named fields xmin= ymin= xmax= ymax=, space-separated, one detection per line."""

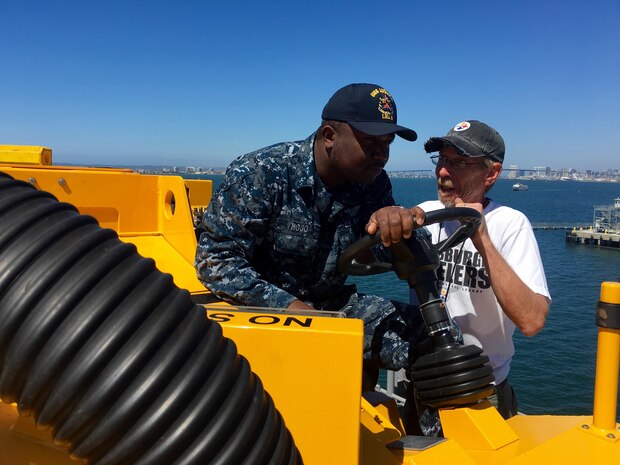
xmin=0 ymin=156 xmax=212 ymax=292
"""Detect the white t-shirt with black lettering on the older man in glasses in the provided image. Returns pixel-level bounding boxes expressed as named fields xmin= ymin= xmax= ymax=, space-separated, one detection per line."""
xmin=411 ymin=200 xmax=550 ymax=384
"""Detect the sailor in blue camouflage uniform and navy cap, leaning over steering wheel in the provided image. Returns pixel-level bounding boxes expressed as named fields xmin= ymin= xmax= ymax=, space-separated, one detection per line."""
xmin=195 ymin=84 xmax=428 ymax=388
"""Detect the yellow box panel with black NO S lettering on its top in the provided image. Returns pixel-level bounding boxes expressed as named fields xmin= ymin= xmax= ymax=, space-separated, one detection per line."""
xmin=207 ymin=305 xmax=363 ymax=465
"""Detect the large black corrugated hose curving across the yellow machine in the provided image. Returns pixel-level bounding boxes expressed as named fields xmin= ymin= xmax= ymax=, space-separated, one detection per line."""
xmin=0 ymin=173 xmax=302 ymax=465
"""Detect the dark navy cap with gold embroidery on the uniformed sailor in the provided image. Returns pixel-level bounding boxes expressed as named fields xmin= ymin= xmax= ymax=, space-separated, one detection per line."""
xmin=321 ymin=84 xmax=418 ymax=141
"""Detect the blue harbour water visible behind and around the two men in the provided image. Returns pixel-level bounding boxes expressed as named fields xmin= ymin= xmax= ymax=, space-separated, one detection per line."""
xmin=209 ymin=176 xmax=620 ymax=419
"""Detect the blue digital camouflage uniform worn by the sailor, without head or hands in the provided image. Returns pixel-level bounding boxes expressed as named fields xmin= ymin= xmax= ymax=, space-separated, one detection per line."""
xmin=195 ymin=134 xmax=428 ymax=370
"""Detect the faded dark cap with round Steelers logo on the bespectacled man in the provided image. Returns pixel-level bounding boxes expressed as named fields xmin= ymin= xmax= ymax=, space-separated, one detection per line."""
xmin=424 ymin=119 xmax=506 ymax=163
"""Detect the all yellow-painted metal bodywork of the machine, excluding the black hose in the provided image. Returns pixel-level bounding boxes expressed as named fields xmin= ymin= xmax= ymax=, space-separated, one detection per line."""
xmin=0 ymin=146 xmax=620 ymax=465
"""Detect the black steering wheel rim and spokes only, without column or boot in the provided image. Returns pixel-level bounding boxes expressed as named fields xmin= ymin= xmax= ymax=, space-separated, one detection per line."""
xmin=338 ymin=207 xmax=482 ymax=276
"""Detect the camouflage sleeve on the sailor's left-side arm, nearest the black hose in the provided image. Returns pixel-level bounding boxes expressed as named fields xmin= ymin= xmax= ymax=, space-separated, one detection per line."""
xmin=194 ymin=167 xmax=296 ymax=308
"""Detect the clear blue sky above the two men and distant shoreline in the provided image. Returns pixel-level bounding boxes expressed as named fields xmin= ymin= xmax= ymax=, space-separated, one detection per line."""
xmin=0 ymin=0 xmax=620 ymax=170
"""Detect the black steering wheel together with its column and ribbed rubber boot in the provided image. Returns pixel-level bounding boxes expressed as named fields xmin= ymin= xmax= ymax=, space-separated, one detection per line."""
xmin=338 ymin=207 xmax=494 ymax=408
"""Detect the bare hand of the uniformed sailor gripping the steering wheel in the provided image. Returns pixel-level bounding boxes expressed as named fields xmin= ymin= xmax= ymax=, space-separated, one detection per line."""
xmin=366 ymin=206 xmax=425 ymax=247
